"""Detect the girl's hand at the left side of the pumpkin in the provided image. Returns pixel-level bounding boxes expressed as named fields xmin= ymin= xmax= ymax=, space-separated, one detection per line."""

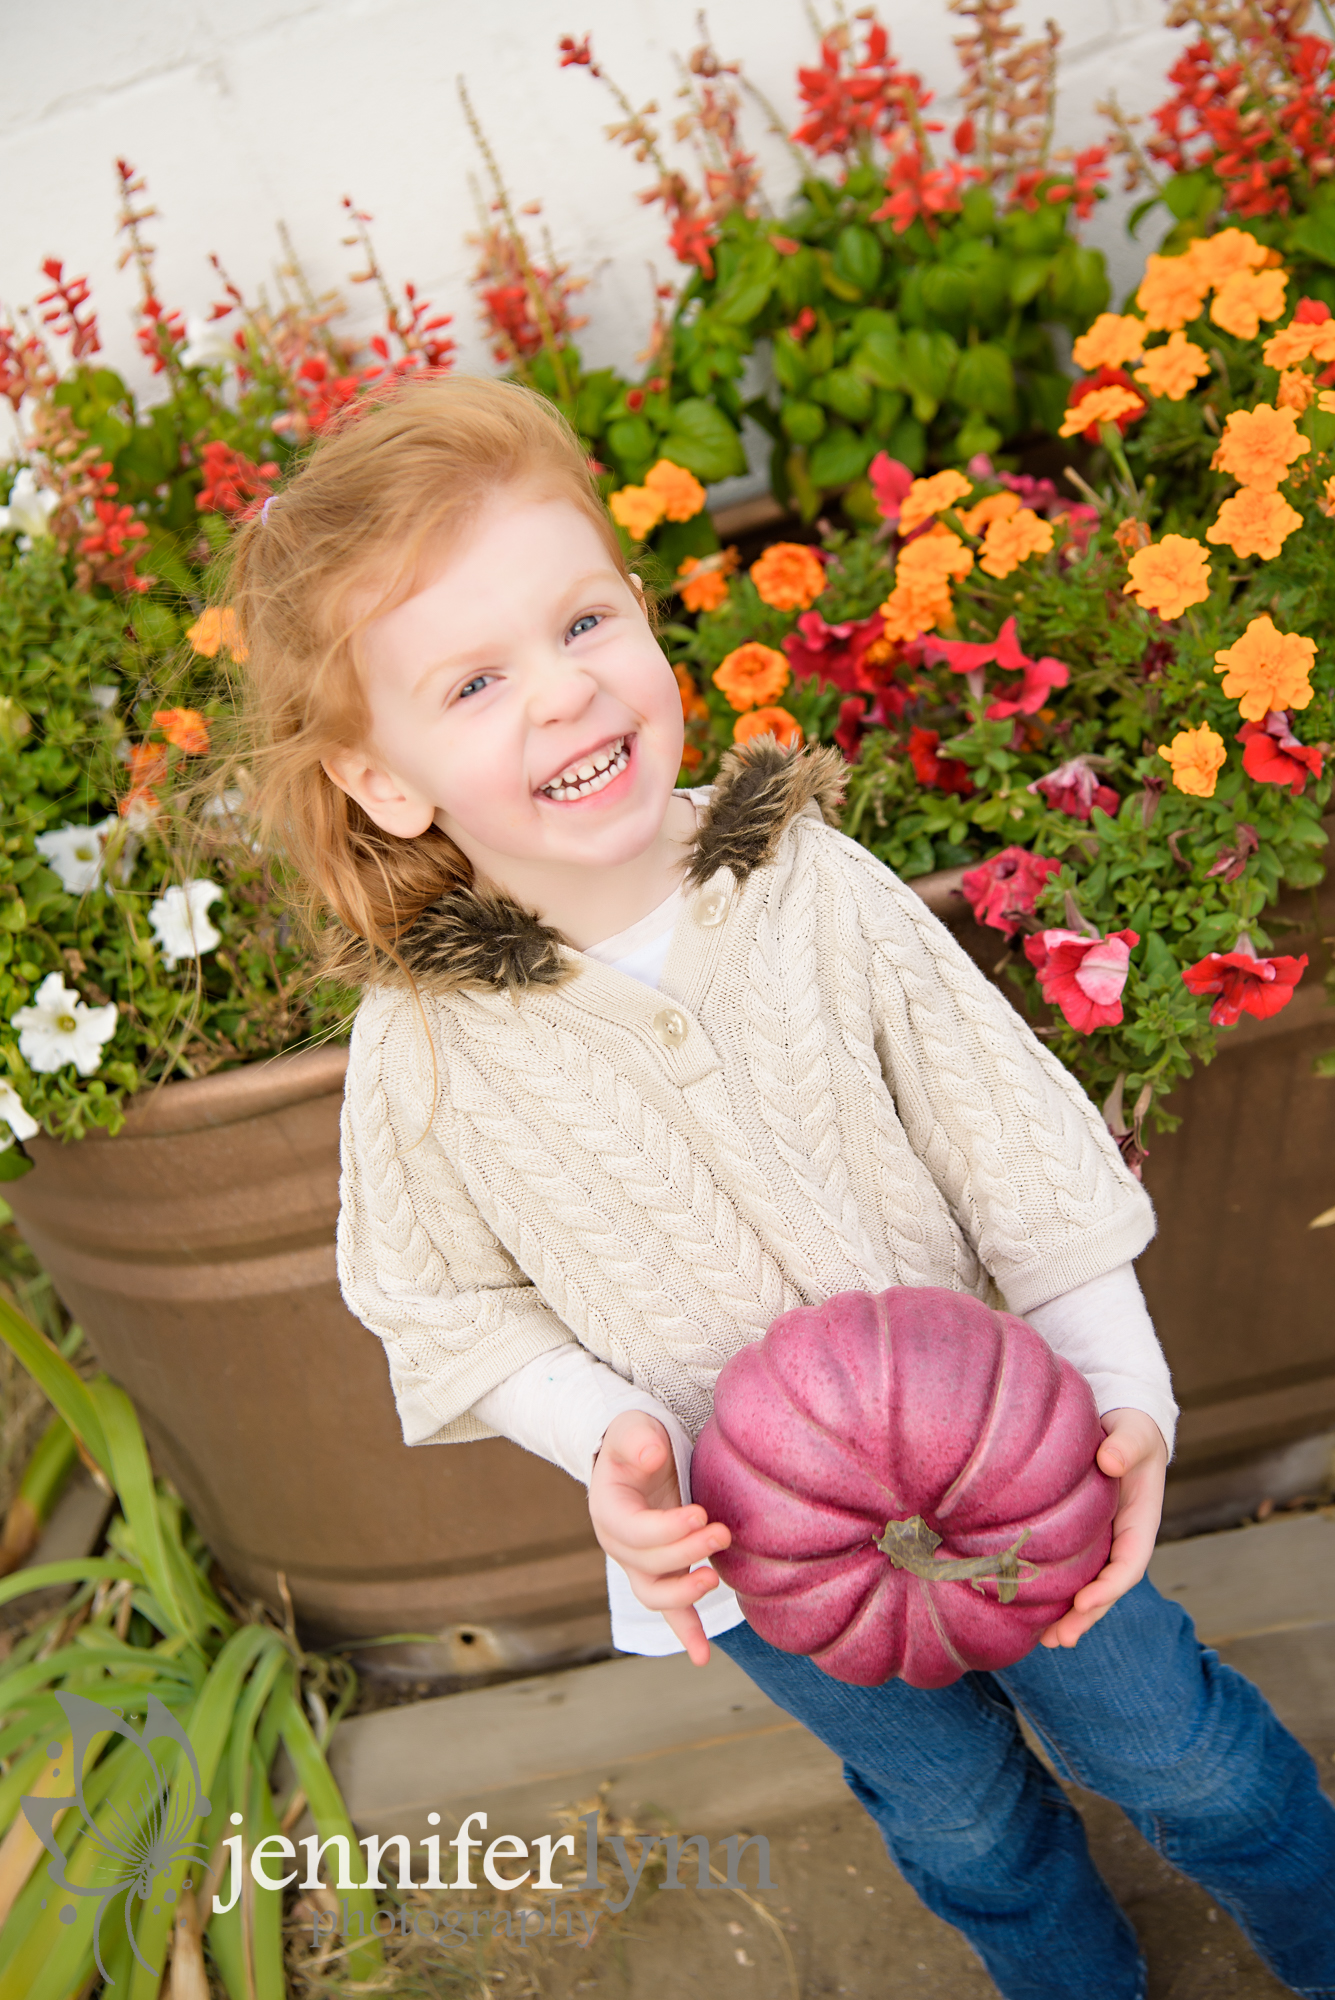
xmin=590 ymin=1410 xmax=731 ymax=1666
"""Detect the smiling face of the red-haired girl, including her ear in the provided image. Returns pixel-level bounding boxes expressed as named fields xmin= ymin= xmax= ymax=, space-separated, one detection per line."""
xmin=326 ymin=490 xmax=681 ymax=890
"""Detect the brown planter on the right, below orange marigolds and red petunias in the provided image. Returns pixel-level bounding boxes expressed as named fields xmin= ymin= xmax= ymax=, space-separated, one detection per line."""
xmin=913 ymin=848 xmax=1335 ymax=1532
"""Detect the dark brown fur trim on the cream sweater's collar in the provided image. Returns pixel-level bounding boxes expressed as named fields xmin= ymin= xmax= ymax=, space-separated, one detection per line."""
xmin=346 ymin=736 xmax=843 ymax=994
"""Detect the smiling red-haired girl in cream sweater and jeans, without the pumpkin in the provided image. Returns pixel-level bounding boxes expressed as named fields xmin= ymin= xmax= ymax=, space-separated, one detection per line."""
xmin=234 ymin=378 xmax=1335 ymax=2000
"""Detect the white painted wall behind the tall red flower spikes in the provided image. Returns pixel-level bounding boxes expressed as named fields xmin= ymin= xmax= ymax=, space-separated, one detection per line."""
xmin=0 ymin=0 xmax=1181 ymax=418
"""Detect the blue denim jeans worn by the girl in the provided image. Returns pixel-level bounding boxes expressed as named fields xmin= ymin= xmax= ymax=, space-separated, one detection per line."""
xmin=713 ymin=1578 xmax=1335 ymax=2000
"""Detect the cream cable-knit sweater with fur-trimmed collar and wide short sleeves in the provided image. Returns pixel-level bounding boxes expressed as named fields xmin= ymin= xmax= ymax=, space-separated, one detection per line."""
xmin=338 ymin=742 xmax=1171 ymax=1444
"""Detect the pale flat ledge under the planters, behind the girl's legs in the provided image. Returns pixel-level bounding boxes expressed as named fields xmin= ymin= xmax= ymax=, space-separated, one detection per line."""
xmin=330 ymin=1508 xmax=1335 ymax=1840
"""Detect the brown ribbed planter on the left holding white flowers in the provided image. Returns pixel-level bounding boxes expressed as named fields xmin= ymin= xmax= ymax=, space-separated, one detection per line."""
xmin=6 ymin=1048 xmax=610 ymax=1676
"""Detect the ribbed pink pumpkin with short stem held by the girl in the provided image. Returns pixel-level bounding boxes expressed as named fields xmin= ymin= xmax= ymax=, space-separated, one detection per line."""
xmin=691 ymin=1286 xmax=1117 ymax=1688
